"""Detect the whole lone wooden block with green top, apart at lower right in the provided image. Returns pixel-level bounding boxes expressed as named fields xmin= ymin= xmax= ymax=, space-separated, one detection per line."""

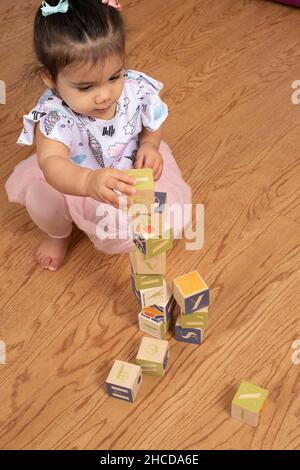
xmin=231 ymin=381 xmax=269 ymax=427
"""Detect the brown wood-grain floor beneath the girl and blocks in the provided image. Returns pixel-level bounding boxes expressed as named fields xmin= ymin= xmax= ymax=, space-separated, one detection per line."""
xmin=0 ymin=0 xmax=300 ymax=450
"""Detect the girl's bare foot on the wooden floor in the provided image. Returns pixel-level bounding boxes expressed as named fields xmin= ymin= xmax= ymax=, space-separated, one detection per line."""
xmin=35 ymin=235 xmax=71 ymax=271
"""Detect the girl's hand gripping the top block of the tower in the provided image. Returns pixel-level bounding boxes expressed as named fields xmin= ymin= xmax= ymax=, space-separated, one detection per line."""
xmin=85 ymin=168 xmax=136 ymax=209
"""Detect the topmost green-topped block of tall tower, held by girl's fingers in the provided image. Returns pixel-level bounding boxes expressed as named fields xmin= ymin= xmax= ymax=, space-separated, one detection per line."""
xmin=123 ymin=168 xmax=155 ymax=210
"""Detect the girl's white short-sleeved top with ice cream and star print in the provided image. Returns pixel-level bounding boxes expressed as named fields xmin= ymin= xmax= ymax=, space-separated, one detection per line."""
xmin=17 ymin=69 xmax=168 ymax=169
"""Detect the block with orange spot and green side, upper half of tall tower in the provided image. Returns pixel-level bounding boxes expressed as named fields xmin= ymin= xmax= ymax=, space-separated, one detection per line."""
xmin=133 ymin=224 xmax=173 ymax=258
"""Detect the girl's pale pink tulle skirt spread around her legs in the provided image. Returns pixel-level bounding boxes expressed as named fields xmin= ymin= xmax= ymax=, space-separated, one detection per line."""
xmin=5 ymin=141 xmax=192 ymax=254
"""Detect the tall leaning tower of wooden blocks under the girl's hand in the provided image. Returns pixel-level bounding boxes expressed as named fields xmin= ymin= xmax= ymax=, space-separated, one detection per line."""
xmin=126 ymin=169 xmax=176 ymax=339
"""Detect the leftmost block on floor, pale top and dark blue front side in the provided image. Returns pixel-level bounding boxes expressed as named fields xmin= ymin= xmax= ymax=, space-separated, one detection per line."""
xmin=106 ymin=360 xmax=142 ymax=403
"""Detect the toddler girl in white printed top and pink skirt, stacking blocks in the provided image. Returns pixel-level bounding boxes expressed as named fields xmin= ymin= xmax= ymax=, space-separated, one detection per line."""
xmin=6 ymin=0 xmax=191 ymax=271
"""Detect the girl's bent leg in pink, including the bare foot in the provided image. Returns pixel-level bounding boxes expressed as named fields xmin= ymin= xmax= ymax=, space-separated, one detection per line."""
xmin=25 ymin=179 xmax=72 ymax=271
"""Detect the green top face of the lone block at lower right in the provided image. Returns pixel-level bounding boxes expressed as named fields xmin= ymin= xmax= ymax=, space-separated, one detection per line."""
xmin=232 ymin=381 xmax=269 ymax=414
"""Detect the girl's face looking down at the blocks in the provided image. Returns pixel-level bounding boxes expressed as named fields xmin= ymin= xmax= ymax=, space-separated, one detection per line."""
xmin=43 ymin=56 xmax=124 ymax=120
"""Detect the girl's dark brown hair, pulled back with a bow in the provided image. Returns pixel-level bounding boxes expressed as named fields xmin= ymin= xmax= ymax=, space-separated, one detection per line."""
xmin=32 ymin=0 xmax=126 ymax=83
